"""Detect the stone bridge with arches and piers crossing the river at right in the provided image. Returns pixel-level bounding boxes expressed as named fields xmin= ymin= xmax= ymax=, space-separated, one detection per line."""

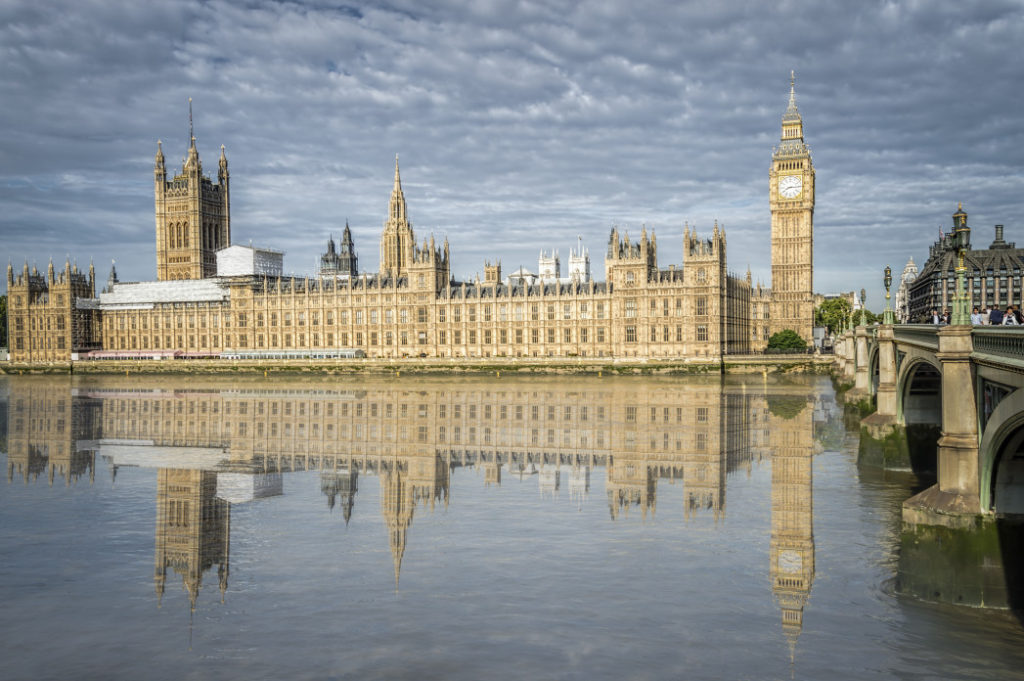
xmin=836 ymin=325 xmax=1024 ymax=527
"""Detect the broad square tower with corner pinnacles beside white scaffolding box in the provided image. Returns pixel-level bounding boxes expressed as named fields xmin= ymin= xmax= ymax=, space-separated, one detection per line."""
xmin=153 ymin=99 xmax=231 ymax=281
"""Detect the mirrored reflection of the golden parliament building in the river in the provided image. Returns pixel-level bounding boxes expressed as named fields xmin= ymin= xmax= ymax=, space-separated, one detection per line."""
xmin=7 ymin=378 xmax=828 ymax=649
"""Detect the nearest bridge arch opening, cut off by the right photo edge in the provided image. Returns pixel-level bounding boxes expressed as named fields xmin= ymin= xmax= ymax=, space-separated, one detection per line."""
xmin=979 ymin=389 xmax=1024 ymax=517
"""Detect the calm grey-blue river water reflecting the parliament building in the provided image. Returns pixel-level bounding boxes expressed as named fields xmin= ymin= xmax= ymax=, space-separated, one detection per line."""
xmin=0 ymin=376 xmax=1024 ymax=680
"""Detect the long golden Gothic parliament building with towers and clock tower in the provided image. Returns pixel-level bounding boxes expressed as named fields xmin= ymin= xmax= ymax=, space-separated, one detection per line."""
xmin=7 ymin=80 xmax=814 ymax=361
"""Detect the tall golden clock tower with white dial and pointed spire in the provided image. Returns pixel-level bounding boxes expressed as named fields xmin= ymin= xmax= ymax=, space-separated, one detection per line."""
xmin=760 ymin=72 xmax=814 ymax=342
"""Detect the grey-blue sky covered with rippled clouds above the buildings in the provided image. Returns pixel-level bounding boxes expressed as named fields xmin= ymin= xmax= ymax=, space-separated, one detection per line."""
xmin=0 ymin=0 xmax=1024 ymax=308
